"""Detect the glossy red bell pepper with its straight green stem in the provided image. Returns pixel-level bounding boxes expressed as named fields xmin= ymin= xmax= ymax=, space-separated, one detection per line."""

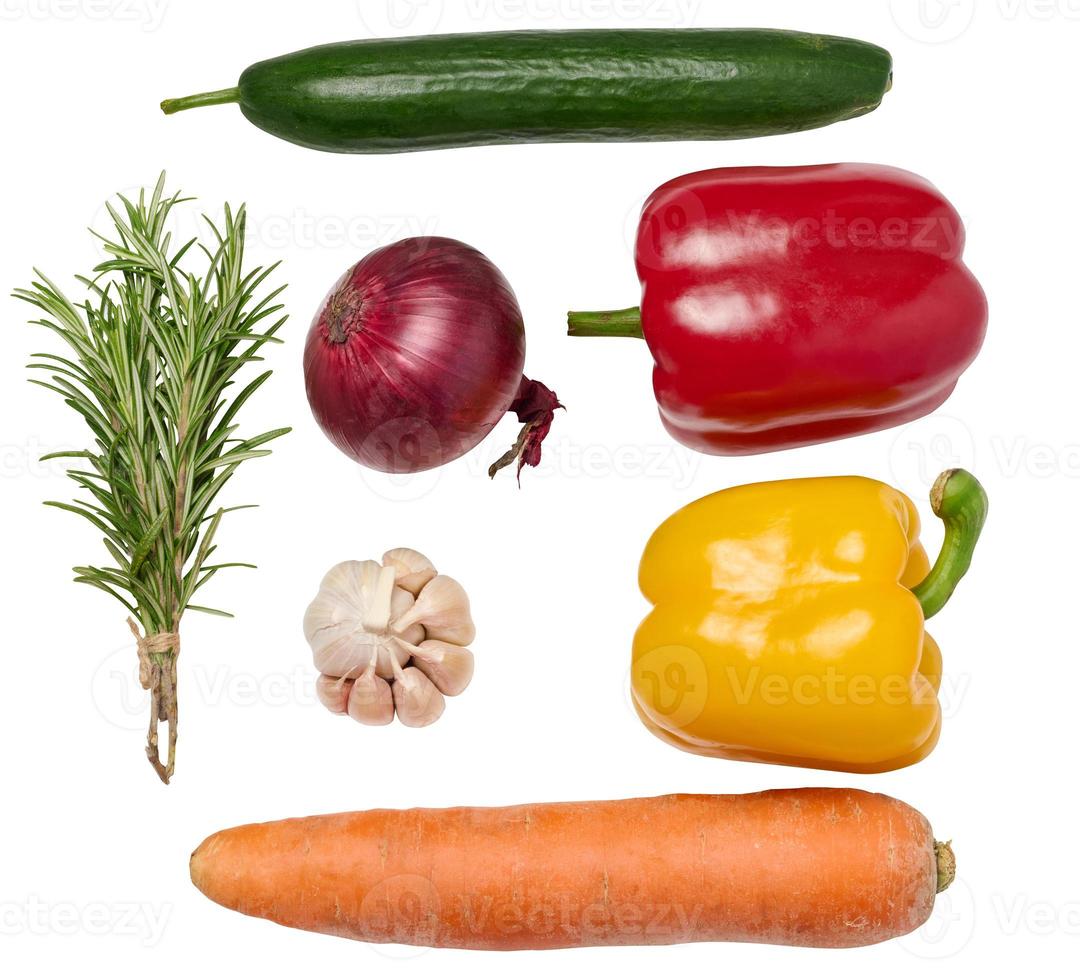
xmin=569 ymin=163 xmax=987 ymax=455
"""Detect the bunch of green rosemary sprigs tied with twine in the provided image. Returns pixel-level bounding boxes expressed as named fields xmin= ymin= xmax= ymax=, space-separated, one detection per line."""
xmin=14 ymin=174 xmax=288 ymax=783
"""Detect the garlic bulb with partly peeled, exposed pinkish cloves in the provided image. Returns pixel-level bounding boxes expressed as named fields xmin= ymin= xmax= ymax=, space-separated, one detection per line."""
xmin=303 ymin=548 xmax=476 ymax=728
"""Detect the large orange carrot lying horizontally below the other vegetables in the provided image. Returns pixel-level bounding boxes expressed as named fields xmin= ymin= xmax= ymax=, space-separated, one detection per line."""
xmin=191 ymin=789 xmax=954 ymax=950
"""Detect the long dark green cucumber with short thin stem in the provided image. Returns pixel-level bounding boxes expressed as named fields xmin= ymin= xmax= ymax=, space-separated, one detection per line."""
xmin=161 ymin=29 xmax=892 ymax=153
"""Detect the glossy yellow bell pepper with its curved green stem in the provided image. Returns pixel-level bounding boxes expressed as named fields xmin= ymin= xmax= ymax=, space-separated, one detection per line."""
xmin=632 ymin=470 xmax=987 ymax=773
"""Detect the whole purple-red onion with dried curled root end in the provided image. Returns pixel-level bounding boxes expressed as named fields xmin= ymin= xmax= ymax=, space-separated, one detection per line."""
xmin=303 ymin=238 xmax=562 ymax=476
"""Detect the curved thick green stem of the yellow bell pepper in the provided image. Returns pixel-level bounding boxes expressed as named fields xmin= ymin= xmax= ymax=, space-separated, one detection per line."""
xmin=912 ymin=470 xmax=989 ymax=619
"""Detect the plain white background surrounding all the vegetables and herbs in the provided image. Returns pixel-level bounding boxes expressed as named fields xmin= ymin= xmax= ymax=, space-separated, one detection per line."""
xmin=0 ymin=0 xmax=1080 ymax=980
